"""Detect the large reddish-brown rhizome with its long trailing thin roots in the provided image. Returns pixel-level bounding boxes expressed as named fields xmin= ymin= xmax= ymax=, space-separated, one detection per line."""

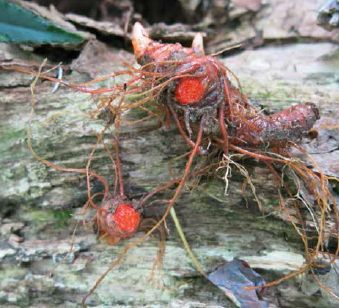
xmin=13 ymin=31 xmax=339 ymax=304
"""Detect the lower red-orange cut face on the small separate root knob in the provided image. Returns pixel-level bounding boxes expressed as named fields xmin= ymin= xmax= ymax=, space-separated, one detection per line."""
xmin=113 ymin=203 xmax=140 ymax=233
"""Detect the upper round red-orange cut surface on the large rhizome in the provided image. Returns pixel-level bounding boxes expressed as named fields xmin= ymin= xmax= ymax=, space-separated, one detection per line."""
xmin=175 ymin=77 xmax=205 ymax=105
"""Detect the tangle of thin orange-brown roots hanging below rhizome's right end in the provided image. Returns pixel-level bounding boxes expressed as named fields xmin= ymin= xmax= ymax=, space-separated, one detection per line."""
xmin=217 ymin=145 xmax=339 ymax=294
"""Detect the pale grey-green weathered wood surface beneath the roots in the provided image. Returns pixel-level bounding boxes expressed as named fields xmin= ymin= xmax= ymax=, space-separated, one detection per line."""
xmin=0 ymin=39 xmax=339 ymax=307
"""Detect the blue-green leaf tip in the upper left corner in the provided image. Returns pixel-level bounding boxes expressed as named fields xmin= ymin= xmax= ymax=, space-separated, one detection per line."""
xmin=0 ymin=0 xmax=85 ymax=45
